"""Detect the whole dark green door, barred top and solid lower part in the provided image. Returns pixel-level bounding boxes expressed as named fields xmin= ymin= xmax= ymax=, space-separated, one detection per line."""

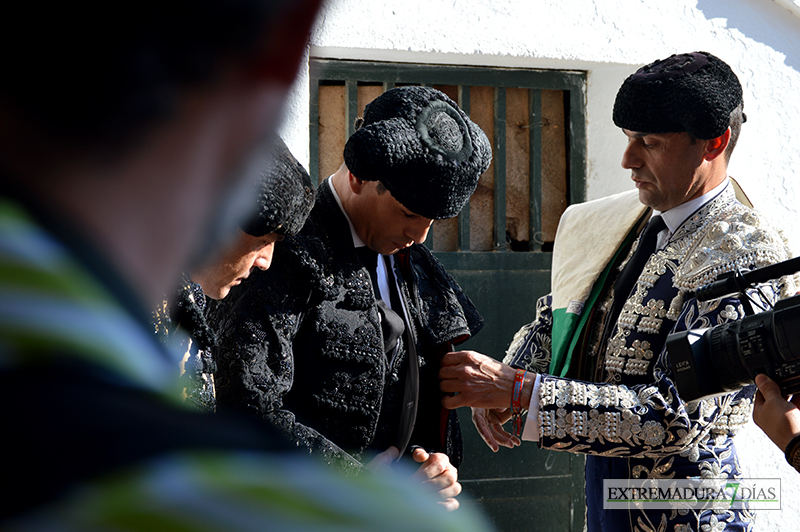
xmin=309 ymin=58 xmax=586 ymax=532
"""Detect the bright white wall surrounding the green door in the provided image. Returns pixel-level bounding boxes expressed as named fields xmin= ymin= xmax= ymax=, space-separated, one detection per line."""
xmin=284 ymin=0 xmax=800 ymax=530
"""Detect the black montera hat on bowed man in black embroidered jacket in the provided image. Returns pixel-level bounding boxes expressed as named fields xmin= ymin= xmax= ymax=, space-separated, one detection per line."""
xmin=344 ymin=86 xmax=492 ymax=220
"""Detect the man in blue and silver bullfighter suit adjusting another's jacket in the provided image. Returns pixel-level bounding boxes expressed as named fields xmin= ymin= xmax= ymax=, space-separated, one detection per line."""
xmin=440 ymin=53 xmax=795 ymax=532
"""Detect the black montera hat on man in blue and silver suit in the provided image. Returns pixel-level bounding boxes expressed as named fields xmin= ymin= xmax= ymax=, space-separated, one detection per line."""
xmin=614 ymin=52 xmax=742 ymax=140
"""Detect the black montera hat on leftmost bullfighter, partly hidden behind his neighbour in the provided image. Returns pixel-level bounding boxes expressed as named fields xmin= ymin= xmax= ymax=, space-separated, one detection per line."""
xmin=241 ymin=137 xmax=316 ymax=236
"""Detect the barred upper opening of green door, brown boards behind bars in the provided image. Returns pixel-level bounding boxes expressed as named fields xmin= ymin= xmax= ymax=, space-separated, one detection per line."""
xmin=310 ymin=59 xmax=586 ymax=253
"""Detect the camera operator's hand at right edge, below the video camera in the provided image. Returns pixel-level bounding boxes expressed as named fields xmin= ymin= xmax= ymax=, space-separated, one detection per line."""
xmin=753 ymin=373 xmax=800 ymax=451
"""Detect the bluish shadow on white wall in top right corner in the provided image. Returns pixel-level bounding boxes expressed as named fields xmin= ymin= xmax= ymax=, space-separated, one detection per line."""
xmin=697 ymin=0 xmax=800 ymax=70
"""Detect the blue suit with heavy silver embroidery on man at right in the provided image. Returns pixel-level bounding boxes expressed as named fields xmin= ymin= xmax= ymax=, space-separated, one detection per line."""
xmin=505 ymin=187 xmax=796 ymax=531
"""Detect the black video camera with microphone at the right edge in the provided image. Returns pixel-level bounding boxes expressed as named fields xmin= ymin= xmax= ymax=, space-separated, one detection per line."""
xmin=666 ymin=257 xmax=800 ymax=402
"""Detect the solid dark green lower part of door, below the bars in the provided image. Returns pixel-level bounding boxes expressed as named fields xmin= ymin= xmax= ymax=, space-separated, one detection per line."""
xmin=438 ymin=253 xmax=584 ymax=532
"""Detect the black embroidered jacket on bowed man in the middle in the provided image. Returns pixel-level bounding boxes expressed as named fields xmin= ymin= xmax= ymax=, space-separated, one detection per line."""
xmin=211 ymin=183 xmax=483 ymax=467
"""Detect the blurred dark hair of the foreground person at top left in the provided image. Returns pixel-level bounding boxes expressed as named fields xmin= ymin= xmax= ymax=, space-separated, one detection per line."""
xmin=0 ymin=0 xmax=291 ymax=152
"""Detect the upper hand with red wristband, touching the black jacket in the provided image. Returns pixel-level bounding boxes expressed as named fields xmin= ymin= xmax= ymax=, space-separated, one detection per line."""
xmin=439 ymin=351 xmax=534 ymax=410
